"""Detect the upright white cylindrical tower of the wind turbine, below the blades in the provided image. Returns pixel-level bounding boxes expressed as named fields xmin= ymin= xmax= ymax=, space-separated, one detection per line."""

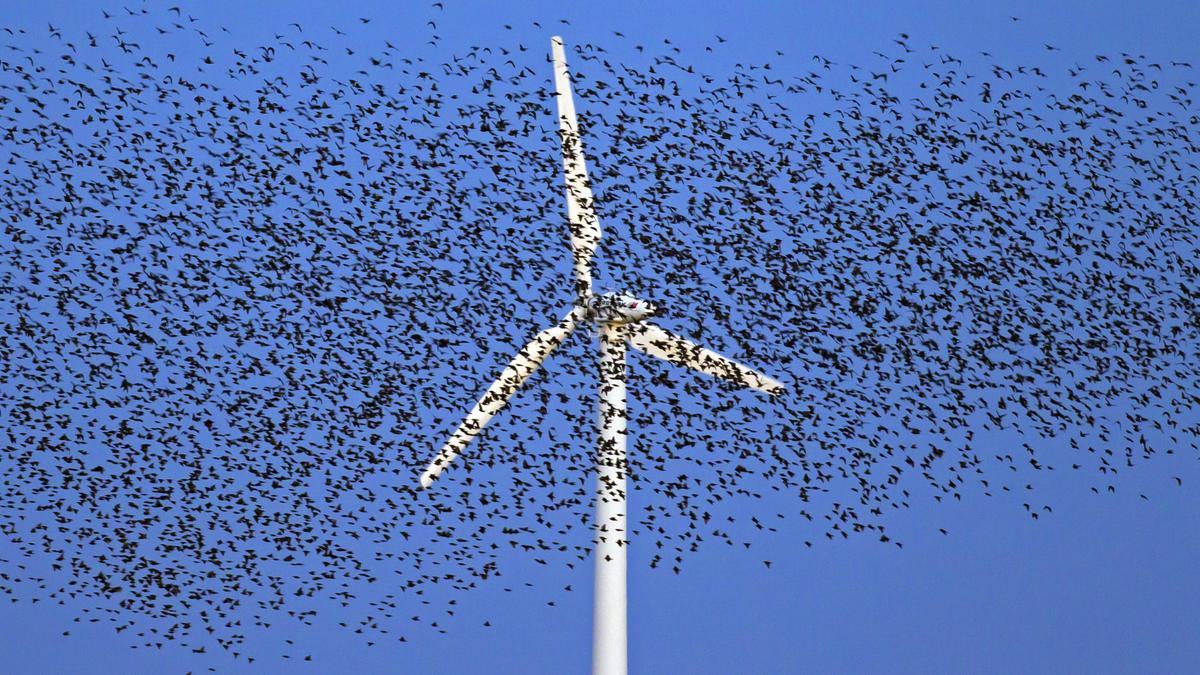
xmin=592 ymin=323 xmax=629 ymax=675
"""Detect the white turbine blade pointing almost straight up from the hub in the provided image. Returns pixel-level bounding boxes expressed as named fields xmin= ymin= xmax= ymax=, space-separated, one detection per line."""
xmin=550 ymin=36 xmax=600 ymax=297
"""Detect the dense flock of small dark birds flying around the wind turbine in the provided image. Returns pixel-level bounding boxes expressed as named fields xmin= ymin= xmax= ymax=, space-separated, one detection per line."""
xmin=0 ymin=1 xmax=1200 ymax=652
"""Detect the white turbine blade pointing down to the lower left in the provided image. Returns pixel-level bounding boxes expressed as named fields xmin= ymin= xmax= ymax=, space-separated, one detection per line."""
xmin=421 ymin=309 xmax=582 ymax=488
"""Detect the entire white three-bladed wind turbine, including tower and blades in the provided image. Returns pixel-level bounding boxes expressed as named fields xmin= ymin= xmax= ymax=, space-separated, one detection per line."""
xmin=421 ymin=37 xmax=784 ymax=675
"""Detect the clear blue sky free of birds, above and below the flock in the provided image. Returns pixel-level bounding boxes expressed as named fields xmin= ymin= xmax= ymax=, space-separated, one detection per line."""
xmin=0 ymin=0 xmax=1200 ymax=674
